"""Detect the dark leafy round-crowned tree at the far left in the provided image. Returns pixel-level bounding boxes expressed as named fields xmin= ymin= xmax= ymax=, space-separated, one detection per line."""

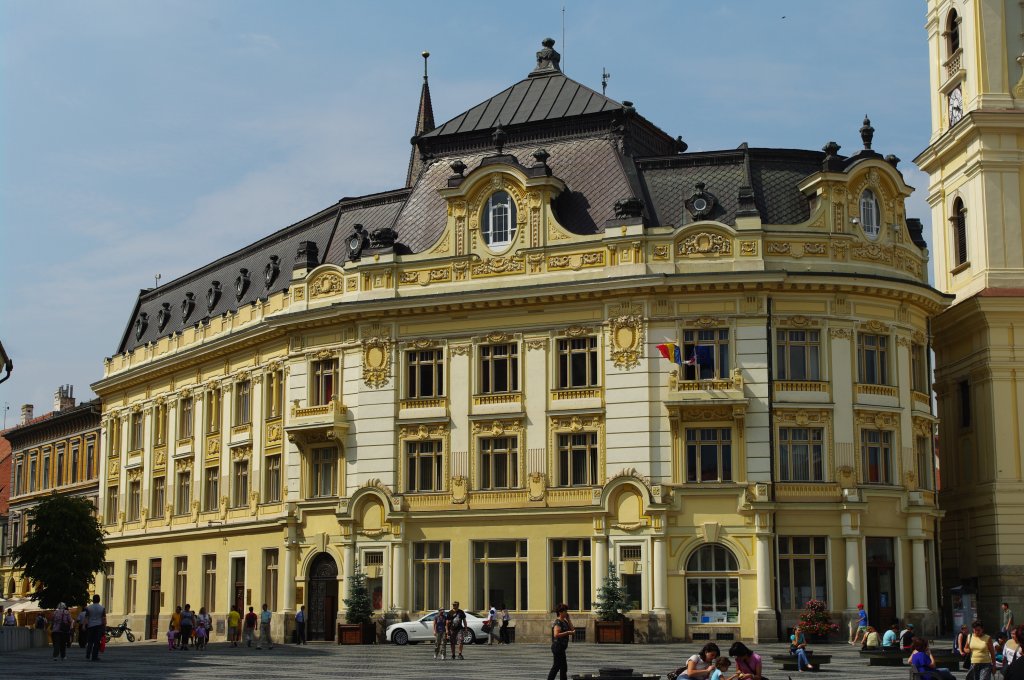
xmin=11 ymin=495 xmax=106 ymax=609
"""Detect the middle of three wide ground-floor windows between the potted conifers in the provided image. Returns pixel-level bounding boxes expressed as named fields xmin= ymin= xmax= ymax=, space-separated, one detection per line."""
xmin=473 ymin=541 xmax=529 ymax=611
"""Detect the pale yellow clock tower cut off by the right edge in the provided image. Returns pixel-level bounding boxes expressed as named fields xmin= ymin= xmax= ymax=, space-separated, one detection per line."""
xmin=915 ymin=0 xmax=1024 ymax=632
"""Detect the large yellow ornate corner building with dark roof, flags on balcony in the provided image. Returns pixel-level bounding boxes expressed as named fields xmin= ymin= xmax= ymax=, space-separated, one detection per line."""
xmin=94 ymin=41 xmax=947 ymax=641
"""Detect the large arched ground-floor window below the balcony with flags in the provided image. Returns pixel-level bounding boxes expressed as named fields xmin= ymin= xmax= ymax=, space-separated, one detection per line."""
xmin=686 ymin=543 xmax=739 ymax=624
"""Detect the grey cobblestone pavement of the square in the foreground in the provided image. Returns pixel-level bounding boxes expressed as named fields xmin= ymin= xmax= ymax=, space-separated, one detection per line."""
xmin=0 ymin=640 xmax=966 ymax=680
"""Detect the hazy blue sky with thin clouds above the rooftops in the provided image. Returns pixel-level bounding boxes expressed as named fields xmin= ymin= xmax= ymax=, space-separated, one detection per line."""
xmin=0 ymin=0 xmax=930 ymax=419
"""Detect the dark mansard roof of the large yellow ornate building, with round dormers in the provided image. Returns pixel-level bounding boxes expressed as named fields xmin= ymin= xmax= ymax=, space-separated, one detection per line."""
xmin=118 ymin=41 xmax=925 ymax=352
